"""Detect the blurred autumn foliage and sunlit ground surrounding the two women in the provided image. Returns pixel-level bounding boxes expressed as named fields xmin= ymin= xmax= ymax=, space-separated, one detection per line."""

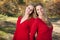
xmin=0 ymin=0 xmax=60 ymax=40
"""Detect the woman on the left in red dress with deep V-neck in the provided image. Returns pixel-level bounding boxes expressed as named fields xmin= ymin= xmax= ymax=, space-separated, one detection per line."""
xmin=13 ymin=4 xmax=34 ymax=40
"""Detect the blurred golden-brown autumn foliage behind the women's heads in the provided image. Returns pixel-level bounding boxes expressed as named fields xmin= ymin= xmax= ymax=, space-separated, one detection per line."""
xmin=0 ymin=0 xmax=60 ymax=17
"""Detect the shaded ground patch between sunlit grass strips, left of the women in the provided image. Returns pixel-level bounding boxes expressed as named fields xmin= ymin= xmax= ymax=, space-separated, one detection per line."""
xmin=0 ymin=21 xmax=15 ymax=34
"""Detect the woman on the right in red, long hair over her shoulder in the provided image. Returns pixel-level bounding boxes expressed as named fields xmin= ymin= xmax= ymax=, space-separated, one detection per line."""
xmin=30 ymin=3 xmax=53 ymax=40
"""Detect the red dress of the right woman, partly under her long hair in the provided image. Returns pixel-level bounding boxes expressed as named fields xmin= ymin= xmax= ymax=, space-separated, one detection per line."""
xmin=30 ymin=18 xmax=53 ymax=40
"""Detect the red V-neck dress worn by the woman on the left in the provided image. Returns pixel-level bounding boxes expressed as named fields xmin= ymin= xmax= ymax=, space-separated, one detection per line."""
xmin=13 ymin=17 xmax=34 ymax=40
